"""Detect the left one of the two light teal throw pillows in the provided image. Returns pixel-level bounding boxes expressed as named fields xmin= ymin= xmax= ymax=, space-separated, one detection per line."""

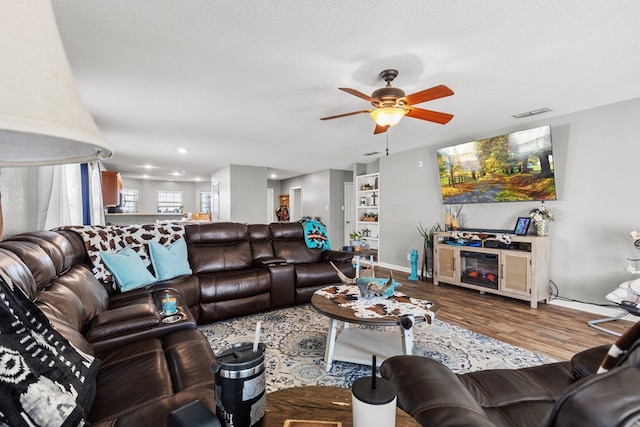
xmin=100 ymin=247 xmax=156 ymax=292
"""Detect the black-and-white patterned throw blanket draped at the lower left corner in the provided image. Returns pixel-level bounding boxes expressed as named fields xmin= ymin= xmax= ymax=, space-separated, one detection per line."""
xmin=0 ymin=277 xmax=99 ymax=426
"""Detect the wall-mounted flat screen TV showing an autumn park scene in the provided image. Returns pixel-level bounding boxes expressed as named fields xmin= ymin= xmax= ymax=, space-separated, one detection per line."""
xmin=438 ymin=126 xmax=556 ymax=204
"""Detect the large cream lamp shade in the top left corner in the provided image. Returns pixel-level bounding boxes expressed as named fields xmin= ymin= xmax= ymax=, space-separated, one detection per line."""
xmin=0 ymin=0 xmax=112 ymax=166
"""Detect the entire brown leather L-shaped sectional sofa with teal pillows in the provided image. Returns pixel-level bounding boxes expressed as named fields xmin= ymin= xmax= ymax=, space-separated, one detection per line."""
xmin=0 ymin=223 xmax=352 ymax=426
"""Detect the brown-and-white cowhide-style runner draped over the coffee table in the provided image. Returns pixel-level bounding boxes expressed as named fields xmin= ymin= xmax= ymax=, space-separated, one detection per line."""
xmin=316 ymin=285 xmax=436 ymax=323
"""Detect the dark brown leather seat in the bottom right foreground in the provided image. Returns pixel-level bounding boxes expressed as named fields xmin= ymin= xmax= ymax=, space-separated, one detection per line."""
xmin=380 ymin=334 xmax=640 ymax=427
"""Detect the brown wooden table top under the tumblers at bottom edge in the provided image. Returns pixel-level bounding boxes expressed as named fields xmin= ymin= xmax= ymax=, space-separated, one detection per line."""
xmin=264 ymin=386 xmax=420 ymax=427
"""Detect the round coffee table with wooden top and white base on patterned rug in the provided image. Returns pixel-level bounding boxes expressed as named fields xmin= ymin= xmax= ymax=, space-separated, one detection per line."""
xmin=311 ymin=284 xmax=440 ymax=371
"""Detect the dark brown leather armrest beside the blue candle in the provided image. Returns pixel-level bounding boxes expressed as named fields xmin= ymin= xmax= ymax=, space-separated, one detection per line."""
xmin=86 ymin=304 xmax=160 ymax=342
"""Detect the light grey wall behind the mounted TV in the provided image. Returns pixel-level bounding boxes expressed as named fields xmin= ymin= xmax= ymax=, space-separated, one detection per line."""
xmin=380 ymin=99 xmax=640 ymax=303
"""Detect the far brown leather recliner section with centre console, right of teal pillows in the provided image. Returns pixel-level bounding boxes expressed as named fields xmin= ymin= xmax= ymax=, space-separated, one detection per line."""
xmin=185 ymin=222 xmax=353 ymax=324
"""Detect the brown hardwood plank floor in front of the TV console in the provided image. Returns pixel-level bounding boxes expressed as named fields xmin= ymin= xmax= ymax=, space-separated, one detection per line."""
xmin=376 ymin=268 xmax=633 ymax=360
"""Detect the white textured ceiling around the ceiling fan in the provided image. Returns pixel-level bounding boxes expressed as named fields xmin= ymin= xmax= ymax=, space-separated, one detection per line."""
xmin=53 ymin=0 xmax=640 ymax=180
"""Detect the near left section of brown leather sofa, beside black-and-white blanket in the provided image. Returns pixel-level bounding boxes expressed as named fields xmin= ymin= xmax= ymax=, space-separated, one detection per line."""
xmin=0 ymin=231 xmax=215 ymax=426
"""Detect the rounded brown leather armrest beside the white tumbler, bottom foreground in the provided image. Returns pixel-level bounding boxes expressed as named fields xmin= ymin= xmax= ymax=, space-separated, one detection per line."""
xmin=380 ymin=356 xmax=495 ymax=427
